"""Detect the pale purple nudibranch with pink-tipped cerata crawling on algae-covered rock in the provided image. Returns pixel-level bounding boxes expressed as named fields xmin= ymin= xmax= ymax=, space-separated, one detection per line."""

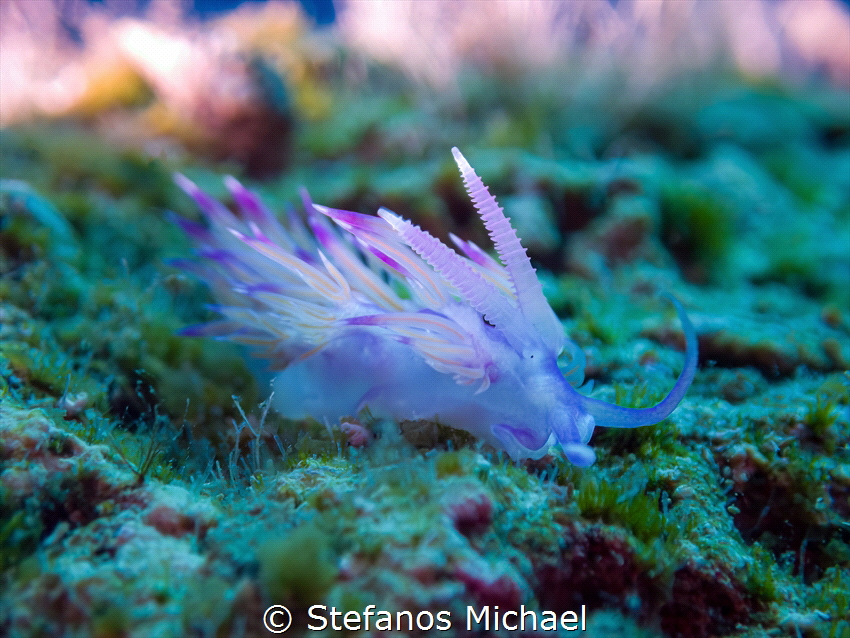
xmin=176 ymin=148 xmax=697 ymax=466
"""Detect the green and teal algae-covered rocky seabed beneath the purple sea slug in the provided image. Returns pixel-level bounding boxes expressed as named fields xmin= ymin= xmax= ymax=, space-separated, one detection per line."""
xmin=0 ymin=2 xmax=850 ymax=638
